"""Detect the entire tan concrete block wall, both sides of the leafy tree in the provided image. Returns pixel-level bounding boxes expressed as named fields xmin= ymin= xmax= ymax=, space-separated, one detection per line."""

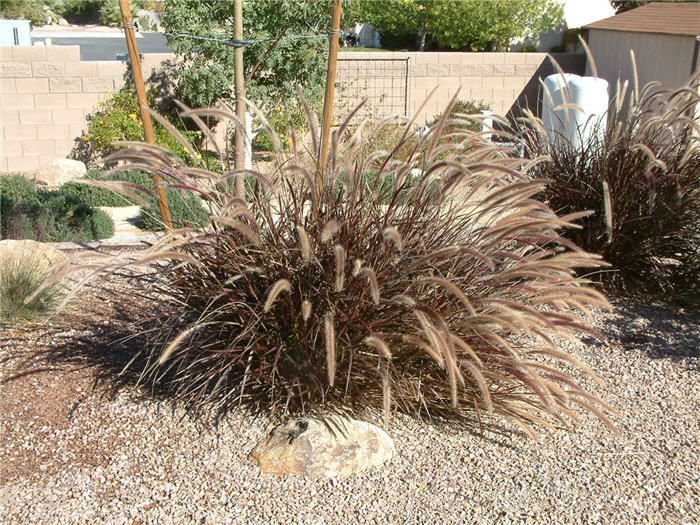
xmin=0 ymin=46 xmax=585 ymax=172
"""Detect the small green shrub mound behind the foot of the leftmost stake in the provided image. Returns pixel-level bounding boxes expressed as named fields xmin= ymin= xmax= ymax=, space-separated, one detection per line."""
xmin=138 ymin=188 xmax=211 ymax=232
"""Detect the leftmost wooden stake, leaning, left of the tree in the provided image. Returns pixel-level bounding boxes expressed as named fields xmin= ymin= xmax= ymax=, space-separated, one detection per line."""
xmin=119 ymin=0 xmax=172 ymax=230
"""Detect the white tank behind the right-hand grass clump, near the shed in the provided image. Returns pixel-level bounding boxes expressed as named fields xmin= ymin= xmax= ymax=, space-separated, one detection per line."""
xmin=542 ymin=73 xmax=610 ymax=148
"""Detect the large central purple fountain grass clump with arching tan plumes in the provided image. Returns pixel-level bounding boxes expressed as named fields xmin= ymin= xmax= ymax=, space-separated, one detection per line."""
xmin=41 ymin=96 xmax=612 ymax=435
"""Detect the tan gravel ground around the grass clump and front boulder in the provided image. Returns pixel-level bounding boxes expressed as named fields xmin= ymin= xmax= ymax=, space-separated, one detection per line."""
xmin=0 ymin=272 xmax=700 ymax=524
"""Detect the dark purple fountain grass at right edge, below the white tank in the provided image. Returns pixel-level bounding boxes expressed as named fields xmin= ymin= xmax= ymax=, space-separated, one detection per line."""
xmin=524 ymin=72 xmax=700 ymax=301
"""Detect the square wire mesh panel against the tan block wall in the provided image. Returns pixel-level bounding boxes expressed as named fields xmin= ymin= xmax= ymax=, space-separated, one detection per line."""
xmin=334 ymin=58 xmax=409 ymax=118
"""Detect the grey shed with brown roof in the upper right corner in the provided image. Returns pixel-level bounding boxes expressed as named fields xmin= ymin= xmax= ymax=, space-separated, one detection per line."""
xmin=586 ymin=2 xmax=700 ymax=91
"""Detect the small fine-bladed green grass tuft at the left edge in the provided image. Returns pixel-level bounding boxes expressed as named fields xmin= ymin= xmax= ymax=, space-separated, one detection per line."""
xmin=0 ymin=253 xmax=63 ymax=326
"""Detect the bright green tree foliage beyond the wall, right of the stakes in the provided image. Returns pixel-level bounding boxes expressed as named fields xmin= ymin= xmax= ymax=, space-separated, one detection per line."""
xmin=347 ymin=0 xmax=564 ymax=51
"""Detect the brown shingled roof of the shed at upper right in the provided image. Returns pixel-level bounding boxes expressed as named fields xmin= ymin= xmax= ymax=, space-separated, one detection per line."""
xmin=585 ymin=2 xmax=700 ymax=36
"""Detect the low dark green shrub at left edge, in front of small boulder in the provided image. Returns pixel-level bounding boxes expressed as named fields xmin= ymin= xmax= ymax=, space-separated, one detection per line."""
xmin=0 ymin=176 xmax=114 ymax=242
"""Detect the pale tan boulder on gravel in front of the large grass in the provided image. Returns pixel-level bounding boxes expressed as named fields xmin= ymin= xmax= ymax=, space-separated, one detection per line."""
xmin=248 ymin=417 xmax=396 ymax=479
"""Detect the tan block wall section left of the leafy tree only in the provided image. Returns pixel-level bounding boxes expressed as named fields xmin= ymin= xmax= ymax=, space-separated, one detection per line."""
xmin=0 ymin=46 xmax=174 ymax=172
